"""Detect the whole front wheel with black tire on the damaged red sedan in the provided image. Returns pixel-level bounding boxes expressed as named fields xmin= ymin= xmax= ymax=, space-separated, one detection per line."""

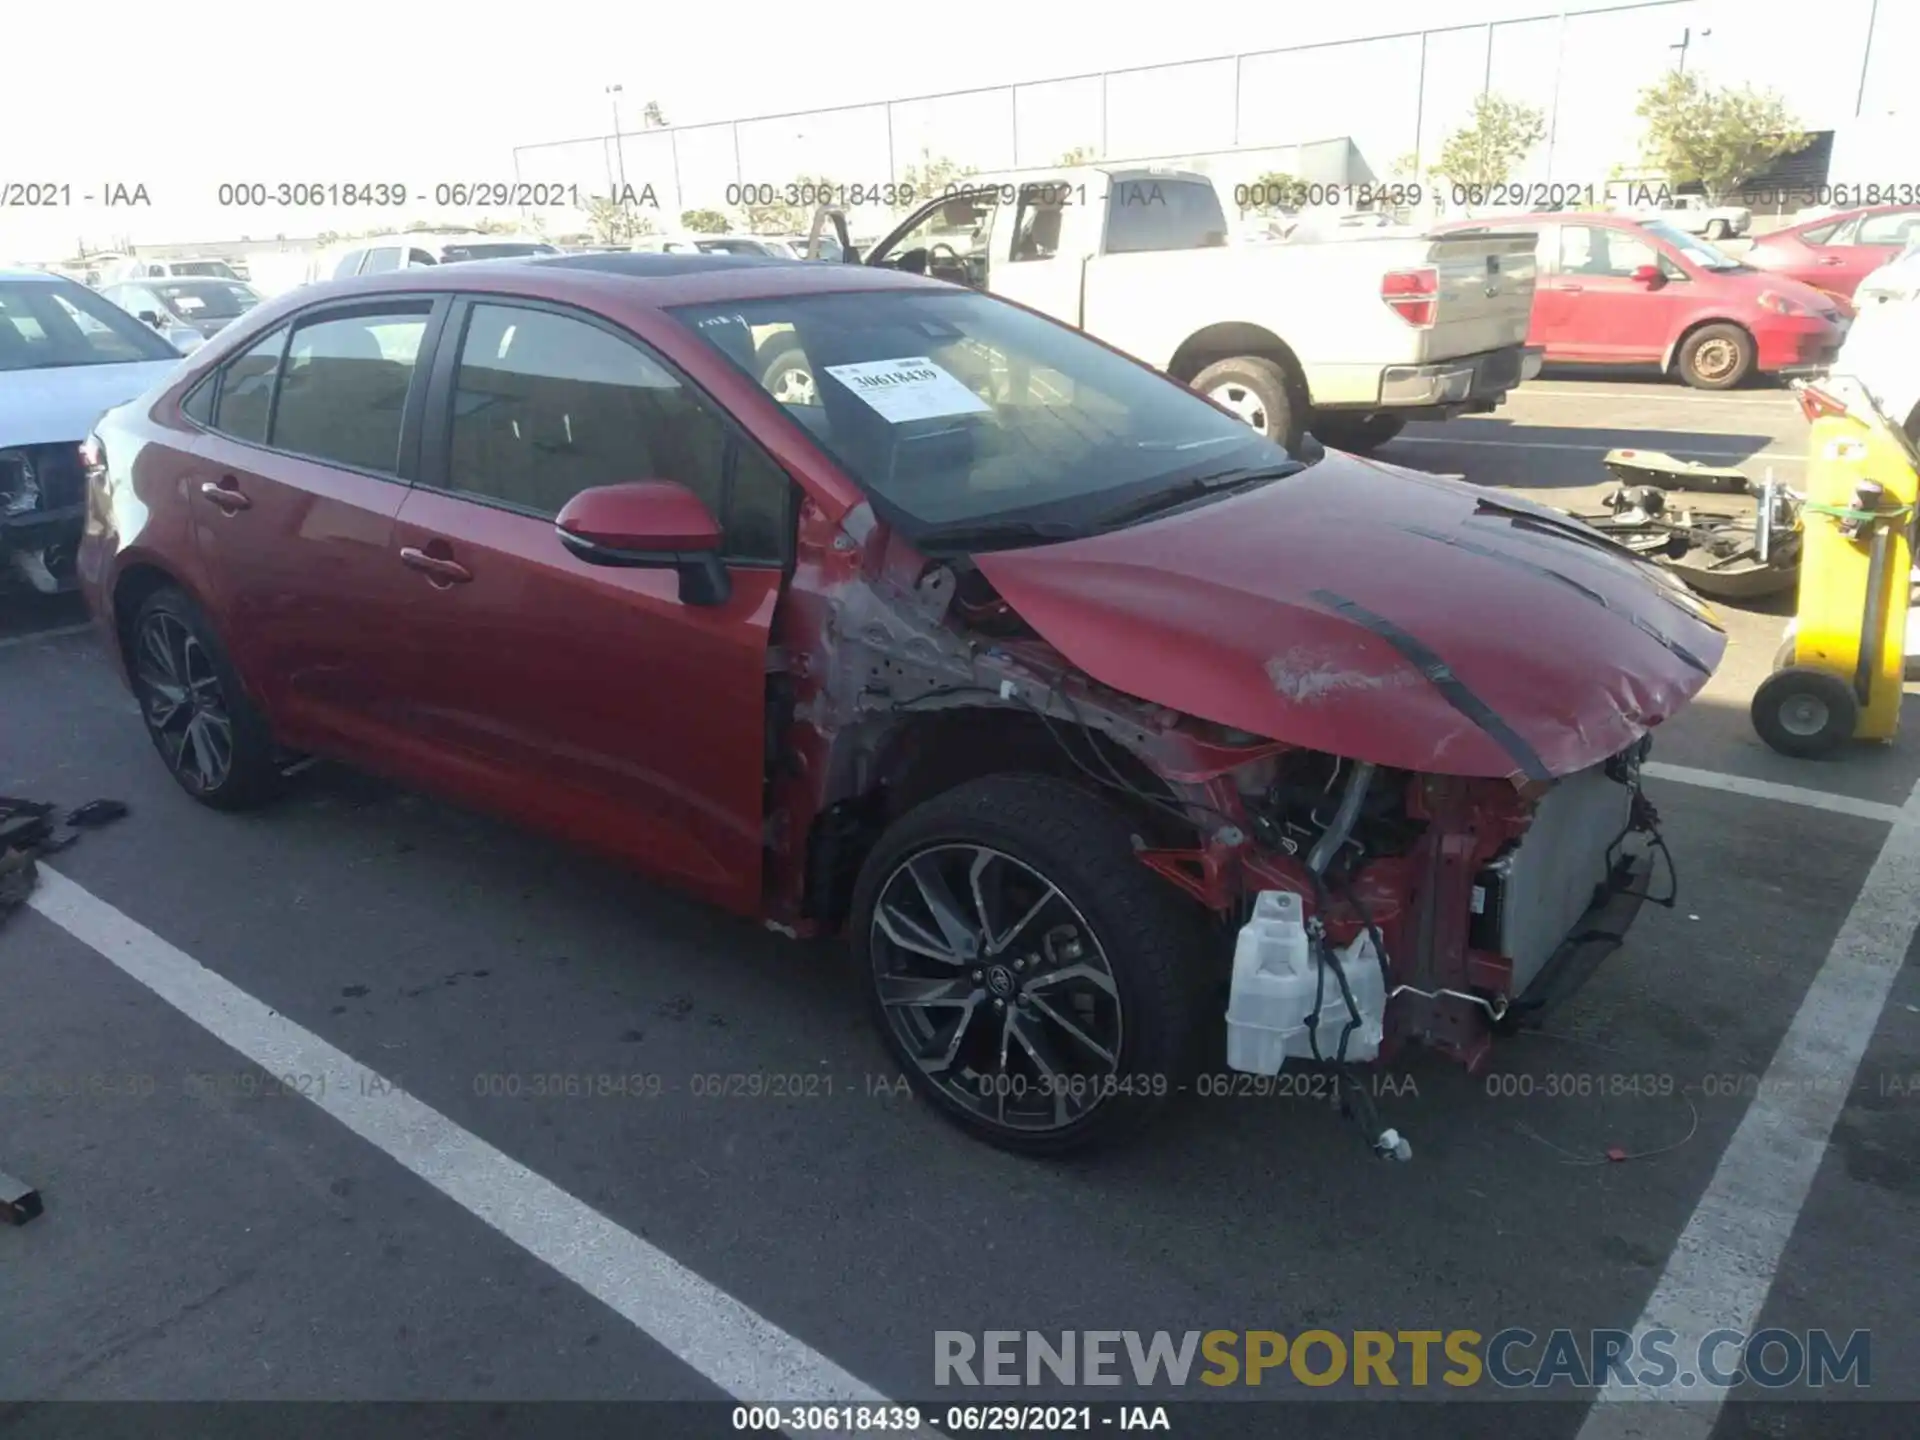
xmin=849 ymin=774 xmax=1208 ymax=1154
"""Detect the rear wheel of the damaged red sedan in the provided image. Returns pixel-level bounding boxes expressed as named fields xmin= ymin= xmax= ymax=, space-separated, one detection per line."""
xmin=127 ymin=588 xmax=284 ymax=810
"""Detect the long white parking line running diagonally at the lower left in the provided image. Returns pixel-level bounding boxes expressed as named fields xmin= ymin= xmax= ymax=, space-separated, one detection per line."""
xmin=27 ymin=866 xmax=939 ymax=1436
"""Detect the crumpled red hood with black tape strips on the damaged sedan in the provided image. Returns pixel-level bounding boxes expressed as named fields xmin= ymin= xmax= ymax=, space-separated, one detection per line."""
xmin=975 ymin=453 xmax=1726 ymax=780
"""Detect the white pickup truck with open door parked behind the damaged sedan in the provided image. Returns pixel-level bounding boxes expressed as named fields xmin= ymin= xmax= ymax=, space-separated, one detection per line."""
xmin=794 ymin=167 xmax=1540 ymax=449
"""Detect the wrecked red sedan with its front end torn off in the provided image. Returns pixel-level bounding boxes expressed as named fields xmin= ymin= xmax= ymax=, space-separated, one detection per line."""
xmin=81 ymin=255 xmax=1724 ymax=1150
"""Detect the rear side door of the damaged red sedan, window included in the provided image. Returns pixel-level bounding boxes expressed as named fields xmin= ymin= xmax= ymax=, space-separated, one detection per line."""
xmin=188 ymin=296 xmax=445 ymax=768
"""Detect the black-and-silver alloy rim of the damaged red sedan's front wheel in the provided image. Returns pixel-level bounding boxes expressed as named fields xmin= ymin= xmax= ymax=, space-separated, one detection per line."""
xmin=868 ymin=843 xmax=1125 ymax=1133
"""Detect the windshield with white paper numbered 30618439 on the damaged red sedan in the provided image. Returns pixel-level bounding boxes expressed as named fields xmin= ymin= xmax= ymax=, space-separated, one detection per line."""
xmin=672 ymin=290 xmax=1298 ymax=549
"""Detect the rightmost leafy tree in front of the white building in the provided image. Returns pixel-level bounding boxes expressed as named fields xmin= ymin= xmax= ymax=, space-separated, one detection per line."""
xmin=1634 ymin=71 xmax=1812 ymax=202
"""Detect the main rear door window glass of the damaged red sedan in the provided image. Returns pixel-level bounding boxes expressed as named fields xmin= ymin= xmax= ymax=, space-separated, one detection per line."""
xmin=270 ymin=303 xmax=428 ymax=474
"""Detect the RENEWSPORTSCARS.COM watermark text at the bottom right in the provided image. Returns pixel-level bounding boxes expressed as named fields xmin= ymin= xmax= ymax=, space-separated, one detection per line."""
xmin=933 ymin=1327 xmax=1872 ymax=1390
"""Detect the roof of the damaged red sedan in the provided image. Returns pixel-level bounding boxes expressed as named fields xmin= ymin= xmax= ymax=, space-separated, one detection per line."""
xmin=294 ymin=252 xmax=956 ymax=309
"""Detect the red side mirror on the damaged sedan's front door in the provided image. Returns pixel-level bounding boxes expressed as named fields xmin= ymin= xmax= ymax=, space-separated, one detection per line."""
xmin=553 ymin=480 xmax=733 ymax=605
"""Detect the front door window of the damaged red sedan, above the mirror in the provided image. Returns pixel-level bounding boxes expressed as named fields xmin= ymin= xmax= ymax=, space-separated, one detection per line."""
xmin=447 ymin=305 xmax=756 ymax=541
